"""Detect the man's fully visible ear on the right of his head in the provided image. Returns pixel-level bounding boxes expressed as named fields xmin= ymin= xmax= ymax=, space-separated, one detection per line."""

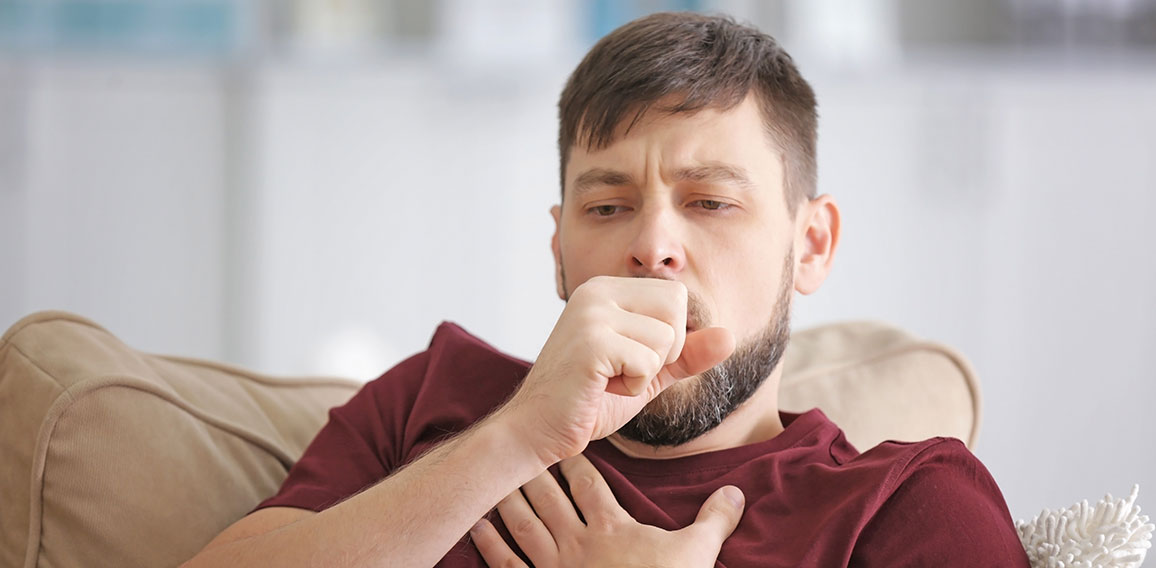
xmin=794 ymin=196 xmax=840 ymax=294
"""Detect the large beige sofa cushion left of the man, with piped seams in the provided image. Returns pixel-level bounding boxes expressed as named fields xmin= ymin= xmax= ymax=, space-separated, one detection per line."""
xmin=0 ymin=312 xmax=360 ymax=567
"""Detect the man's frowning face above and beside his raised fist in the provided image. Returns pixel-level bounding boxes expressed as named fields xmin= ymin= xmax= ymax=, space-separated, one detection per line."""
xmin=554 ymin=97 xmax=795 ymax=445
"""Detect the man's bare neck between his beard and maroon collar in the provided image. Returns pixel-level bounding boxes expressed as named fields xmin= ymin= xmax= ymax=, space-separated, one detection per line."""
xmin=607 ymin=364 xmax=784 ymax=459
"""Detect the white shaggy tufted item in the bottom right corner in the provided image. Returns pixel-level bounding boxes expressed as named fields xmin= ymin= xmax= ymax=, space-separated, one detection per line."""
xmin=1016 ymin=485 xmax=1156 ymax=568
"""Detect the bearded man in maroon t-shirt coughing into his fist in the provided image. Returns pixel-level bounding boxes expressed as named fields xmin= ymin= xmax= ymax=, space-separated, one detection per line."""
xmin=182 ymin=9 xmax=1027 ymax=566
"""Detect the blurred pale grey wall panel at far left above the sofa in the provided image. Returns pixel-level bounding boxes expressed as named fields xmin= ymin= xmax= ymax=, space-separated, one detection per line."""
xmin=0 ymin=61 xmax=228 ymax=355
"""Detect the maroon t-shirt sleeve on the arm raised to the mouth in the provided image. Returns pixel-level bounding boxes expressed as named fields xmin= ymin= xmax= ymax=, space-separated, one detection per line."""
xmin=254 ymin=352 xmax=429 ymax=511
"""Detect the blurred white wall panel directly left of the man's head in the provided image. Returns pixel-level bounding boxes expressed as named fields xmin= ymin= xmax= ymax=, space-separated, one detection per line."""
xmin=246 ymin=61 xmax=564 ymax=378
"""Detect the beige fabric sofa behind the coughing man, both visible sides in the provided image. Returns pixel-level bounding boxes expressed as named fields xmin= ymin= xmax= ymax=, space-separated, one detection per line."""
xmin=0 ymin=311 xmax=979 ymax=568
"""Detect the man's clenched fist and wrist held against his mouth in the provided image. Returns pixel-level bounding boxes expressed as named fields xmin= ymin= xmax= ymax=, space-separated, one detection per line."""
xmin=498 ymin=276 xmax=734 ymax=466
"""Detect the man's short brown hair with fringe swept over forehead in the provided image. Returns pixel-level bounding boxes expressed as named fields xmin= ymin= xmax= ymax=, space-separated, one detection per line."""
xmin=558 ymin=13 xmax=818 ymax=212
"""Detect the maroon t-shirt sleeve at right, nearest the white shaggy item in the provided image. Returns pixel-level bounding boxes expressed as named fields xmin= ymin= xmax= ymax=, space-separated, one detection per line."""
xmin=850 ymin=440 xmax=1030 ymax=567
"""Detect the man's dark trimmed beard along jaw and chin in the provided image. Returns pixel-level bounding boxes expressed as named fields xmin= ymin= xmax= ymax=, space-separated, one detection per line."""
xmin=618 ymin=253 xmax=794 ymax=448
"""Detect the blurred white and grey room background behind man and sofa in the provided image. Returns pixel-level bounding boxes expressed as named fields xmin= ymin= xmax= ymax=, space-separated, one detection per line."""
xmin=0 ymin=0 xmax=1156 ymax=518
